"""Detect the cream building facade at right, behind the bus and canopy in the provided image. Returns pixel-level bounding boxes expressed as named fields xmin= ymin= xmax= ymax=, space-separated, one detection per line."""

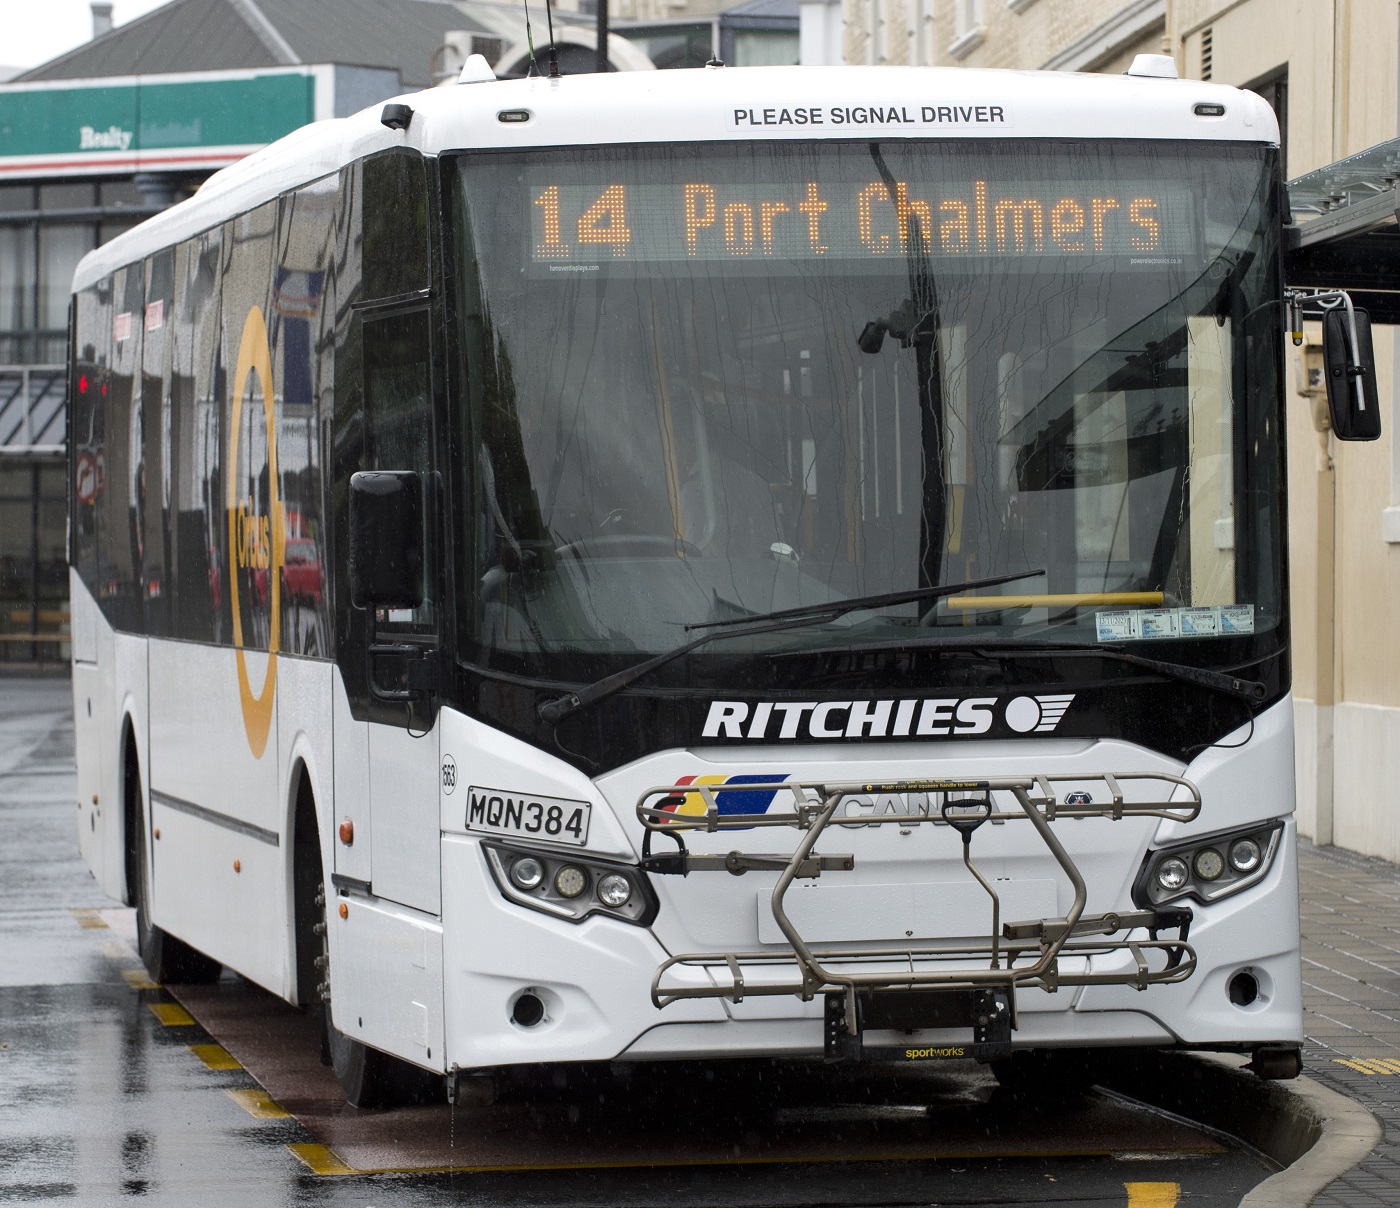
xmin=802 ymin=0 xmax=1400 ymax=861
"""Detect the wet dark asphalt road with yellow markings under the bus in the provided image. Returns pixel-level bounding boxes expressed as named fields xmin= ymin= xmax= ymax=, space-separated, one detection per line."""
xmin=0 ymin=679 xmax=1267 ymax=1208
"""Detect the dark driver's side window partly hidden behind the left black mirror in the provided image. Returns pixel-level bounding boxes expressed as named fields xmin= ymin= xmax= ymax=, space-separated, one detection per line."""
xmin=361 ymin=308 xmax=437 ymax=630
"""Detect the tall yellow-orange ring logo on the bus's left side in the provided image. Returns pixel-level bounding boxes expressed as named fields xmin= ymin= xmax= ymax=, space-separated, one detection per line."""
xmin=228 ymin=307 xmax=287 ymax=759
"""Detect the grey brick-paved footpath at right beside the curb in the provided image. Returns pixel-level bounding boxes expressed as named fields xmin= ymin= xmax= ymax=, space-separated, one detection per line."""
xmin=1298 ymin=840 xmax=1400 ymax=1208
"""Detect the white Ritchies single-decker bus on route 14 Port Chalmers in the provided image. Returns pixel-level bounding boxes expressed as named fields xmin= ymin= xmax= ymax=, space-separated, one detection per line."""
xmin=70 ymin=64 xmax=1332 ymax=1103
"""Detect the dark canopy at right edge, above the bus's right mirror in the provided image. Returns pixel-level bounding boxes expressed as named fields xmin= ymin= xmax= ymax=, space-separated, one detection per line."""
xmin=1284 ymin=139 xmax=1400 ymax=323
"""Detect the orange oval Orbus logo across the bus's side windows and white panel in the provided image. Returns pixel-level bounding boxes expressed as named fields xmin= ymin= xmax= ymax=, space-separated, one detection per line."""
xmin=225 ymin=307 xmax=287 ymax=759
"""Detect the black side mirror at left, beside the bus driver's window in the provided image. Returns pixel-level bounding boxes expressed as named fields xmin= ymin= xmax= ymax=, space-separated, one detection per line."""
xmin=350 ymin=470 xmax=423 ymax=609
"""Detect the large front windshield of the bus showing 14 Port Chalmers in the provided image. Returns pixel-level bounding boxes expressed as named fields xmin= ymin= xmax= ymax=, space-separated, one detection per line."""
xmin=452 ymin=140 xmax=1282 ymax=675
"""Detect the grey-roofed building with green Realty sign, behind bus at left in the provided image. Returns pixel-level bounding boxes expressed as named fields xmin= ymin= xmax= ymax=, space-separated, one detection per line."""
xmin=0 ymin=0 xmax=798 ymax=666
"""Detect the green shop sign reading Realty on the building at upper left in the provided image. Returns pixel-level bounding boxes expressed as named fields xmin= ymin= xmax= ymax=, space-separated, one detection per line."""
xmin=0 ymin=67 xmax=335 ymax=179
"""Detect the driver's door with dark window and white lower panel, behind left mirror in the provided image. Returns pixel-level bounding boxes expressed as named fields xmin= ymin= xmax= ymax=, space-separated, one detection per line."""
xmin=336 ymin=307 xmax=441 ymax=914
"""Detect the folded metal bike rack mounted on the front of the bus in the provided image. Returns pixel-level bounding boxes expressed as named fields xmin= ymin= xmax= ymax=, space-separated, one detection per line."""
xmin=637 ymin=773 xmax=1201 ymax=1061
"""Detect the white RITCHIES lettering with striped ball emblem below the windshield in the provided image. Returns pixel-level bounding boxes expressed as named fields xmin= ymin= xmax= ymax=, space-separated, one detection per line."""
xmin=701 ymin=691 xmax=1074 ymax=742
